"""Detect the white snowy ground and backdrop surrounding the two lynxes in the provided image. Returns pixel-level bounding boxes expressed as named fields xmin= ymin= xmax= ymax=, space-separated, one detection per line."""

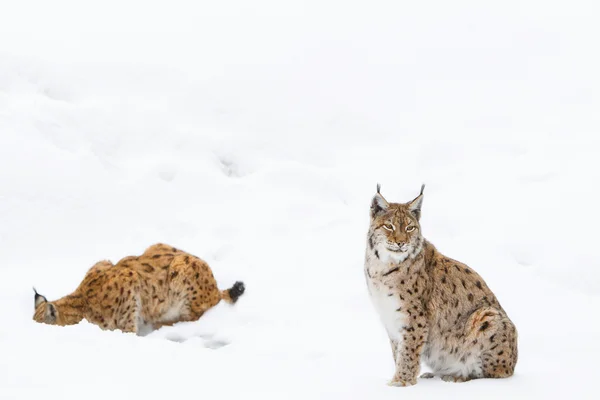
xmin=0 ymin=0 xmax=600 ymax=400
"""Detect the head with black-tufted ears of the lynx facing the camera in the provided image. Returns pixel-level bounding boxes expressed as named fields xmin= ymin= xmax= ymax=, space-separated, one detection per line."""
xmin=368 ymin=184 xmax=425 ymax=262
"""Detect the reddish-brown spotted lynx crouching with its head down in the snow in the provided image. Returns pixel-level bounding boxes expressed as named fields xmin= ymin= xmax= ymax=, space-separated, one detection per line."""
xmin=33 ymin=244 xmax=244 ymax=334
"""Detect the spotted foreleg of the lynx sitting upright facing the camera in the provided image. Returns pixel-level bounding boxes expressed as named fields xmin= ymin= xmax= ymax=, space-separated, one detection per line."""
xmin=388 ymin=319 xmax=427 ymax=386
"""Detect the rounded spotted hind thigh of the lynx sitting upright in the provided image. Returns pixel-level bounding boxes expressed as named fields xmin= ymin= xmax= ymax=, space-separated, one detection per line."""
xmin=467 ymin=307 xmax=518 ymax=378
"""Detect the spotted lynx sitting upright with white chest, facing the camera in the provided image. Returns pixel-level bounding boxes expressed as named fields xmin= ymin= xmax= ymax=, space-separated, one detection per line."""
xmin=365 ymin=185 xmax=517 ymax=386
